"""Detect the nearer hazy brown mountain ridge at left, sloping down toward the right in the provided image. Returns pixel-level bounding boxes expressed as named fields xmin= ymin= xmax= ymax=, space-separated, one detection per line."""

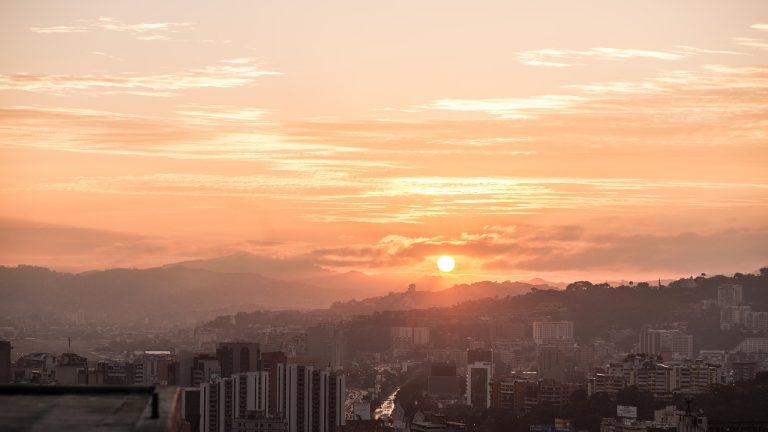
xmin=0 ymin=266 xmax=351 ymax=321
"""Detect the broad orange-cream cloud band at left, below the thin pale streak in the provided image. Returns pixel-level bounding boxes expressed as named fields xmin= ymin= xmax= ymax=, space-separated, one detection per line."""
xmin=0 ymin=105 xmax=388 ymax=176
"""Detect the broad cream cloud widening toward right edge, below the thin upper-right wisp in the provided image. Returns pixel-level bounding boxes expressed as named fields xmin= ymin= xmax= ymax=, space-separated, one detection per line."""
xmin=422 ymin=65 xmax=768 ymax=127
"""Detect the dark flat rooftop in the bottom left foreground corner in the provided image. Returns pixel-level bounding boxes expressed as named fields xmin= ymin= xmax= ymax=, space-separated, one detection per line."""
xmin=0 ymin=385 xmax=183 ymax=432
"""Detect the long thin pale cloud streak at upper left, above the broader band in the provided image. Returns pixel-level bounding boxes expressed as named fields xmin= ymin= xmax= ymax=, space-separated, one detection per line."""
xmin=0 ymin=60 xmax=282 ymax=97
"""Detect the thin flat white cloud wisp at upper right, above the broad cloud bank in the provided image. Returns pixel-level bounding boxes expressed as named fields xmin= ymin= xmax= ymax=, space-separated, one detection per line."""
xmin=517 ymin=45 xmax=740 ymax=67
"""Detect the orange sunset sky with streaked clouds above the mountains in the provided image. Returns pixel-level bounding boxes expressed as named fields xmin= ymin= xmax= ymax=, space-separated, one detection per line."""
xmin=0 ymin=0 xmax=768 ymax=282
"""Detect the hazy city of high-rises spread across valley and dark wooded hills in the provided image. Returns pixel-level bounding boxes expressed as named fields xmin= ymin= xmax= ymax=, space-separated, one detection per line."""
xmin=0 ymin=268 xmax=768 ymax=431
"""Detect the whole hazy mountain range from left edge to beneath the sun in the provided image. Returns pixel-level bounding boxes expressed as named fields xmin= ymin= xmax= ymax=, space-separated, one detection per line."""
xmin=0 ymin=254 xmax=553 ymax=322
